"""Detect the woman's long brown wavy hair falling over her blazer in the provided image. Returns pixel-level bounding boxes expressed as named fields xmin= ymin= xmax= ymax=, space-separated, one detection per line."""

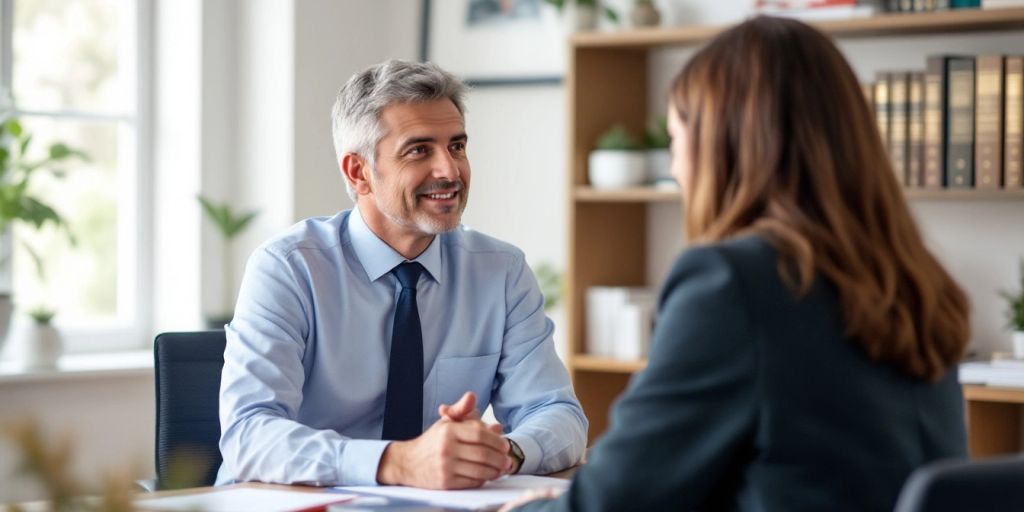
xmin=670 ymin=16 xmax=970 ymax=381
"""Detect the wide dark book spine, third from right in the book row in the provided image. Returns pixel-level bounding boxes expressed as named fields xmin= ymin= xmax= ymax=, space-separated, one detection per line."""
xmin=946 ymin=57 xmax=974 ymax=188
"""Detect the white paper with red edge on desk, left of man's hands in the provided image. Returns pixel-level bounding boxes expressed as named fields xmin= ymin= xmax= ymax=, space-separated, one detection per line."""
xmin=135 ymin=488 xmax=355 ymax=512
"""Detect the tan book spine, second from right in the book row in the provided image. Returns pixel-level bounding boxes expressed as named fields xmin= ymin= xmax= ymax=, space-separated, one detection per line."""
xmin=974 ymin=55 xmax=1004 ymax=188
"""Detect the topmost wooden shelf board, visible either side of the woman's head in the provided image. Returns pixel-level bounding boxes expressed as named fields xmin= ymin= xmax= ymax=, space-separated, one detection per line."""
xmin=571 ymin=8 xmax=1024 ymax=49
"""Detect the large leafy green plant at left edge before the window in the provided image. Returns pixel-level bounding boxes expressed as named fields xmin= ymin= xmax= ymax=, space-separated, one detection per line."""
xmin=0 ymin=116 xmax=89 ymax=354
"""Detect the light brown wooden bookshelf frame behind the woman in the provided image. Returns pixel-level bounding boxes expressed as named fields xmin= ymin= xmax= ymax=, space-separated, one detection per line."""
xmin=565 ymin=8 xmax=1024 ymax=441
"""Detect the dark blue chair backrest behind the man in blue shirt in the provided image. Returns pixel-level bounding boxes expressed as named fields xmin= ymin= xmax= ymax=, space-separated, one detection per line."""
xmin=154 ymin=331 xmax=226 ymax=488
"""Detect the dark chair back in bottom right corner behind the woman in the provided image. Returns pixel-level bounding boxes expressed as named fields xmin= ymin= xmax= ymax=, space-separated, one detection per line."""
xmin=896 ymin=456 xmax=1024 ymax=512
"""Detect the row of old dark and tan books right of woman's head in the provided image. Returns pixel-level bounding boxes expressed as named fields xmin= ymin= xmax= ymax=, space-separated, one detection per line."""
xmin=864 ymin=55 xmax=1024 ymax=189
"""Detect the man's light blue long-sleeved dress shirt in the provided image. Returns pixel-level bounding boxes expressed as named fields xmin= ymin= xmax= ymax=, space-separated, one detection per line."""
xmin=217 ymin=209 xmax=588 ymax=485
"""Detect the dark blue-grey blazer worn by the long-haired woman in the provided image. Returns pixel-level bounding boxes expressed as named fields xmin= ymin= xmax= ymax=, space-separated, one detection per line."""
xmin=525 ymin=236 xmax=966 ymax=511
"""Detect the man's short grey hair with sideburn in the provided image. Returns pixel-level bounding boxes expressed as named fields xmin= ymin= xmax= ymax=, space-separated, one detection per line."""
xmin=331 ymin=59 xmax=466 ymax=202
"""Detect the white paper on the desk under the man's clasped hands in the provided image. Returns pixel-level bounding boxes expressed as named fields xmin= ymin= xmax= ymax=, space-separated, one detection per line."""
xmin=336 ymin=475 xmax=569 ymax=510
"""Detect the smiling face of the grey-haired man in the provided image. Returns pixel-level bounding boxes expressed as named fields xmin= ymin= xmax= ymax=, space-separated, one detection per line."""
xmin=369 ymin=99 xmax=470 ymax=234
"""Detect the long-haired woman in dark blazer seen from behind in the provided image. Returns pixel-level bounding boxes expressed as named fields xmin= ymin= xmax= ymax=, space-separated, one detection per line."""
xmin=509 ymin=17 xmax=969 ymax=511
